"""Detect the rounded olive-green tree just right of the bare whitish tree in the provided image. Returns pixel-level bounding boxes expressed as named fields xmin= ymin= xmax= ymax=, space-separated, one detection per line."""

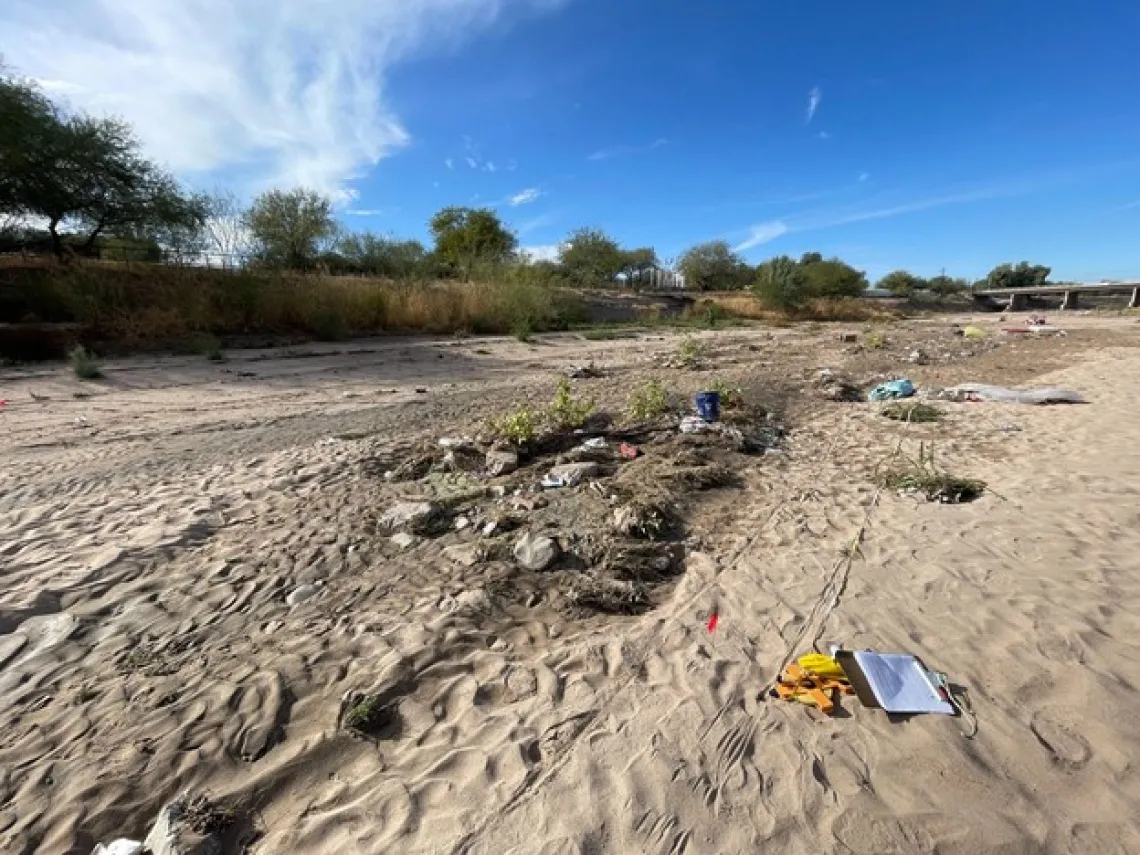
xmin=245 ymin=187 xmax=336 ymax=270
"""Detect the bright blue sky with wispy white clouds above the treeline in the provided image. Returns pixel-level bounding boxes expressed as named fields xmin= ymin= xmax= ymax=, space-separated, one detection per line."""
xmin=0 ymin=0 xmax=1140 ymax=279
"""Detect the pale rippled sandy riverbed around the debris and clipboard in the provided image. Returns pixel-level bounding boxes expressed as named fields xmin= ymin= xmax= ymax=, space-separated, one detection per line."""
xmin=0 ymin=316 xmax=1140 ymax=855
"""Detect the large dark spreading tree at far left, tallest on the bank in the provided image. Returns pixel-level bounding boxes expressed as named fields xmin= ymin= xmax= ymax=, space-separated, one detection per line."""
xmin=0 ymin=74 xmax=206 ymax=257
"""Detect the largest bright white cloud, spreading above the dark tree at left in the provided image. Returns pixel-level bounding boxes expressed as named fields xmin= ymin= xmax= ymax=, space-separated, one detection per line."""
xmin=0 ymin=0 xmax=564 ymax=198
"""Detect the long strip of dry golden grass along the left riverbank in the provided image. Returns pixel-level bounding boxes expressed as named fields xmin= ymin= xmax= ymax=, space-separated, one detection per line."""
xmin=0 ymin=260 xmax=576 ymax=350
